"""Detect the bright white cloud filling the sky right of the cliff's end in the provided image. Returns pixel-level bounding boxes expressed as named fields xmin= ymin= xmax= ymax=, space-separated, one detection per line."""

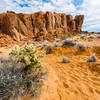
xmin=82 ymin=0 xmax=100 ymax=32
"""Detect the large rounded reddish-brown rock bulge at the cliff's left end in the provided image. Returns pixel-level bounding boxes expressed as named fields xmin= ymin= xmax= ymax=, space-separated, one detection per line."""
xmin=0 ymin=13 xmax=28 ymax=40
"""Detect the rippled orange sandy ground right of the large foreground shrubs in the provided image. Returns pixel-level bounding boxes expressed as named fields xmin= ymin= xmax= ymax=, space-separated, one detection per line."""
xmin=0 ymin=33 xmax=100 ymax=100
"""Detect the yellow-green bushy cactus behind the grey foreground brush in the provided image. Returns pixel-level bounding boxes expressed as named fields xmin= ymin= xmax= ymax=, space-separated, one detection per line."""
xmin=10 ymin=45 xmax=45 ymax=67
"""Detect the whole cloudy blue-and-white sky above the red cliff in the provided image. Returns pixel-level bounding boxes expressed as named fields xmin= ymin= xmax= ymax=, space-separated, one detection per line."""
xmin=0 ymin=0 xmax=100 ymax=32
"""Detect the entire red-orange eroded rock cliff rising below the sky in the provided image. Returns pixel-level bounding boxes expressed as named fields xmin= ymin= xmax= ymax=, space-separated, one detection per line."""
xmin=0 ymin=11 xmax=84 ymax=40
